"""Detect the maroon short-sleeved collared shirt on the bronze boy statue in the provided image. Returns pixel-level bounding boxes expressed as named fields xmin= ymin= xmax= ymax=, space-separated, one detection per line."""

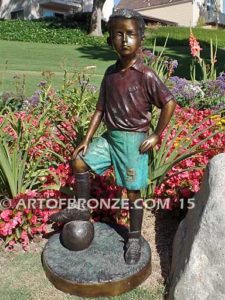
xmin=96 ymin=61 xmax=174 ymax=131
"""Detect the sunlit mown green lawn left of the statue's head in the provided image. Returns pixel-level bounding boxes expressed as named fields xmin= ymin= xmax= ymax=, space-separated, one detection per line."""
xmin=0 ymin=41 xmax=118 ymax=95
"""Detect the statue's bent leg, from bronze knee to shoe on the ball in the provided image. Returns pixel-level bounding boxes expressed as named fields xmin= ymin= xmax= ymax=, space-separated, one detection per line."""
xmin=50 ymin=157 xmax=91 ymax=223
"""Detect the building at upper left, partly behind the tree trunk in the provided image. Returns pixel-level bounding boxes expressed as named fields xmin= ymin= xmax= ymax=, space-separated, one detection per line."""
xmin=0 ymin=0 xmax=114 ymax=21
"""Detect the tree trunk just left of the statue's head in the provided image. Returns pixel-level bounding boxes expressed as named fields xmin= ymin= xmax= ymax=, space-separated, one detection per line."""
xmin=90 ymin=0 xmax=106 ymax=36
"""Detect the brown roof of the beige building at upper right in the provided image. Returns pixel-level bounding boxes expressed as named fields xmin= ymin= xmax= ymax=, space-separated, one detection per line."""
xmin=117 ymin=0 xmax=192 ymax=10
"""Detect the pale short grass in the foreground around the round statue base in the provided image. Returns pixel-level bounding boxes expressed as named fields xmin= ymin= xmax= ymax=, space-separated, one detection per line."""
xmin=0 ymin=251 xmax=163 ymax=300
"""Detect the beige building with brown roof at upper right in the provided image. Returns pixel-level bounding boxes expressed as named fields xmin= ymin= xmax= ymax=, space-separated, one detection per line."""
xmin=117 ymin=0 xmax=225 ymax=26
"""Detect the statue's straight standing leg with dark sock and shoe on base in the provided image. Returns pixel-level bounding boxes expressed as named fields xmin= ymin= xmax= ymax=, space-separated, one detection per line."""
xmin=125 ymin=190 xmax=143 ymax=265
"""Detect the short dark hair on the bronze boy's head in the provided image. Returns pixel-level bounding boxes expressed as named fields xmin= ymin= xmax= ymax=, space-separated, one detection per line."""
xmin=108 ymin=8 xmax=145 ymax=39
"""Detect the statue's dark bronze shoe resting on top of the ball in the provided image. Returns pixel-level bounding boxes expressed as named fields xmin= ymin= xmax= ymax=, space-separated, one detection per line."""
xmin=49 ymin=208 xmax=91 ymax=223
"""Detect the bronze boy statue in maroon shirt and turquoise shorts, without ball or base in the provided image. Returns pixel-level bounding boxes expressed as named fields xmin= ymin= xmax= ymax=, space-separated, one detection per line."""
xmin=51 ymin=9 xmax=176 ymax=264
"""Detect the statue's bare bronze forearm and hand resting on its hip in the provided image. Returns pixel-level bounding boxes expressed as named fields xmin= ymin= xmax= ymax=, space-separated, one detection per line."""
xmin=139 ymin=100 xmax=176 ymax=153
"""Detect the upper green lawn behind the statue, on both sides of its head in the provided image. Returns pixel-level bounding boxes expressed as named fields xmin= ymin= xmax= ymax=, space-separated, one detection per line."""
xmin=0 ymin=36 xmax=225 ymax=96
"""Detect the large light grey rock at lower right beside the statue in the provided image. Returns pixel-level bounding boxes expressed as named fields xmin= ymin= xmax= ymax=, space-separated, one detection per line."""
xmin=167 ymin=153 xmax=225 ymax=300
